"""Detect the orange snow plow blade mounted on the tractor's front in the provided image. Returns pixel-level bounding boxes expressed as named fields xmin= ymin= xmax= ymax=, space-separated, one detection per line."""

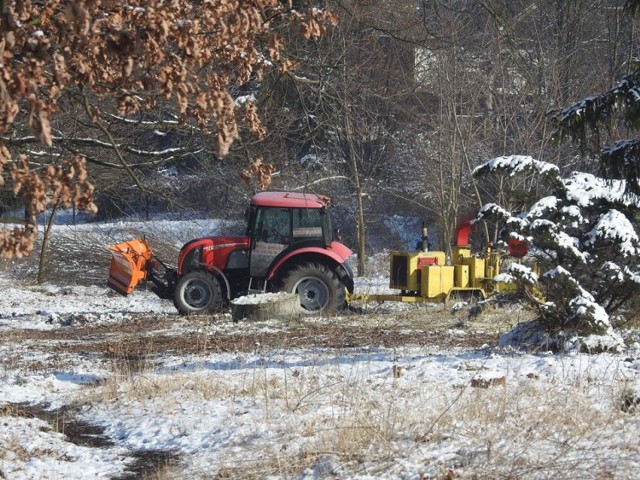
xmin=107 ymin=238 xmax=153 ymax=295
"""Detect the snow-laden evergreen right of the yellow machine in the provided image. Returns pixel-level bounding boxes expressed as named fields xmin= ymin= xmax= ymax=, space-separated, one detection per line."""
xmin=474 ymin=156 xmax=640 ymax=334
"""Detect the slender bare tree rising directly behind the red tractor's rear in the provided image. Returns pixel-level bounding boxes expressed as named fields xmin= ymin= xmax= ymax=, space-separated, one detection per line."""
xmin=250 ymin=1 xmax=418 ymax=274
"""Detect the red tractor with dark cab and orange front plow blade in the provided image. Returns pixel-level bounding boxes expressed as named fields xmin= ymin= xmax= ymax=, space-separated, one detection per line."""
xmin=108 ymin=192 xmax=353 ymax=315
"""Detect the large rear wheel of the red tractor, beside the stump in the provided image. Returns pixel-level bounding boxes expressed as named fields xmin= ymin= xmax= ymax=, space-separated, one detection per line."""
xmin=282 ymin=263 xmax=345 ymax=315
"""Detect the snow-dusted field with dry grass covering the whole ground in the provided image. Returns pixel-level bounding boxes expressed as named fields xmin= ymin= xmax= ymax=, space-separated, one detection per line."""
xmin=0 ymin=221 xmax=640 ymax=480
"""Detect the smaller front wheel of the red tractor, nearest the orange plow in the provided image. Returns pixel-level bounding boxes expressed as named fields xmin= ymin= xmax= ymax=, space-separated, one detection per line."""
xmin=173 ymin=271 xmax=222 ymax=315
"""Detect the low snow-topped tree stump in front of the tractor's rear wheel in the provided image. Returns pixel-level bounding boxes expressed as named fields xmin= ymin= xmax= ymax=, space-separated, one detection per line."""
xmin=231 ymin=292 xmax=302 ymax=322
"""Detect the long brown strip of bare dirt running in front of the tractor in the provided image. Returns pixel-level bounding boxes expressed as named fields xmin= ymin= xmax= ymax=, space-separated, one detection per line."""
xmin=5 ymin=307 xmax=525 ymax=361
